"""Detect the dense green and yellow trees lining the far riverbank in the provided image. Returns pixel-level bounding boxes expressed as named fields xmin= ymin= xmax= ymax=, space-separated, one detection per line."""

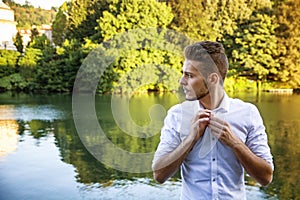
xmin=0 ymin=0 xmax=300 ymax=93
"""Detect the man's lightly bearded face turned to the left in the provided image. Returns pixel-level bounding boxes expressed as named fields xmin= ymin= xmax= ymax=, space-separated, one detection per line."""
xmin=180 ymin=60 xmax=208 ymax=100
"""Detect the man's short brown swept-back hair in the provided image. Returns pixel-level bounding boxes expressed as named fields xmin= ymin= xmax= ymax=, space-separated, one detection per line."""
xmin=184 ymin=41 xmax=228 ymax=81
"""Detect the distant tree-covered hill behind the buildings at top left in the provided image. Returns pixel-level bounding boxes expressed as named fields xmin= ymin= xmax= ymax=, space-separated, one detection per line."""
xmin=3 ymin=0 xmax=56 ymax=29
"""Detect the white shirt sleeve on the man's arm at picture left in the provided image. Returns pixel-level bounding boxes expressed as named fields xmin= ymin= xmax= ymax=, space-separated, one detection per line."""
xmin=153 ymin=106 xmax=181 ymax=162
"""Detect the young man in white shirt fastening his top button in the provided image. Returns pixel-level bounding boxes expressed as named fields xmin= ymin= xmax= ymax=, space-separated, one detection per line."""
xmin=152 ymin=41 xmax=274 ymax=200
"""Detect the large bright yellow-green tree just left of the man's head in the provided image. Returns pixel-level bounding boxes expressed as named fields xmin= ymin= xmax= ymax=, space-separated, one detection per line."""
xmin=89 ymin=0 xmax=182 ymax=92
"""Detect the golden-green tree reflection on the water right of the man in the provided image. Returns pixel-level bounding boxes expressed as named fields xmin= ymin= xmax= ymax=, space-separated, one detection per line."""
xmin=232 ymin=93 xmax=300 ymax=199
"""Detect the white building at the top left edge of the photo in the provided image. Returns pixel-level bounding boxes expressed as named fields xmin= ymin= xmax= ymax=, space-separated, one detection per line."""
xmin=0 ymin=0 xmax=17 ymax=50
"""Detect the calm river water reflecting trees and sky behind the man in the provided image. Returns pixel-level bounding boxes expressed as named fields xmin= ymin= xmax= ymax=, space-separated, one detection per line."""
xmin=0 ymin=93 xmax=300 ymax=200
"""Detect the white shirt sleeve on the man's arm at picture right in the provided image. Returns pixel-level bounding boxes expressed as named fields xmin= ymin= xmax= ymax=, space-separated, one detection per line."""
xmin=246 ymin=104 xmax=274 ymax=170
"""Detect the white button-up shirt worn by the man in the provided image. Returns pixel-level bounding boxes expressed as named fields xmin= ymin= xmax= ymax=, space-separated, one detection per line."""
xmin=154 ymin=94 xmax=274 ymax=200
